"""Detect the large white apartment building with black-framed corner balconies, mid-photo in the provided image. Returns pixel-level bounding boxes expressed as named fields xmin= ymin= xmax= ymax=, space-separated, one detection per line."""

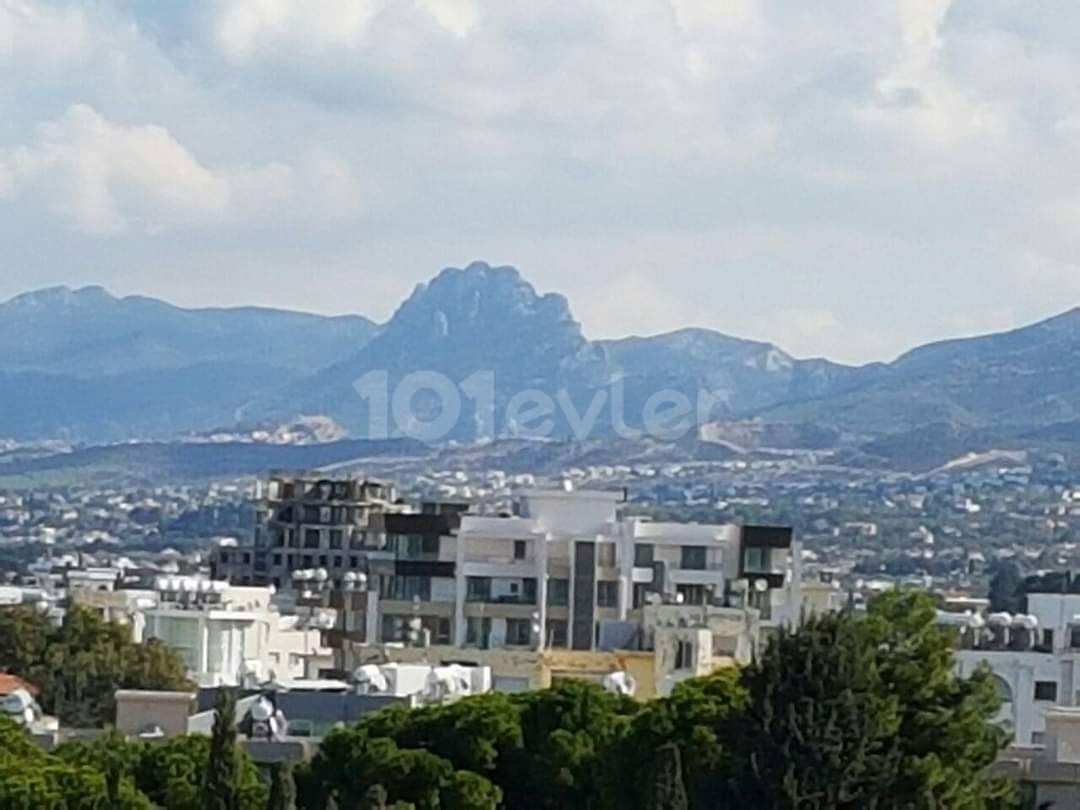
xmin=339 ymin=489 xmax=800 ymax=650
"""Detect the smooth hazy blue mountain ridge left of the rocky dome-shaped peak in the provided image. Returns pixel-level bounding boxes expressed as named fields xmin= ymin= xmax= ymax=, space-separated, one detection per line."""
xmin=0 ymin=287 xmax=377 ymax=441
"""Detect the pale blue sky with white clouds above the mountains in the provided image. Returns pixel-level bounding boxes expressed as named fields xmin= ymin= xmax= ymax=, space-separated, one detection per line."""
xmin=0 ymin=0 xmax=1080 ymax=362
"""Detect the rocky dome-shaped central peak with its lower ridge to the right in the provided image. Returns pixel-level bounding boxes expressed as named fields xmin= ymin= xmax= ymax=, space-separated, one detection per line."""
xmin=245 ymin=262 xmax=852 ymax=438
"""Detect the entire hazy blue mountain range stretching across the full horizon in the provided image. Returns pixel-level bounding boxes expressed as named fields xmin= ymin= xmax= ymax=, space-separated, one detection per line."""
xmin=0 ymin=262 xmax=1080 ymax=468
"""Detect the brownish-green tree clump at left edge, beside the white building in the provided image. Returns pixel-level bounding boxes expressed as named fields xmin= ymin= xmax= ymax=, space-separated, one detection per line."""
xmin=0 ymin=606 xmax=191 ymax=728
